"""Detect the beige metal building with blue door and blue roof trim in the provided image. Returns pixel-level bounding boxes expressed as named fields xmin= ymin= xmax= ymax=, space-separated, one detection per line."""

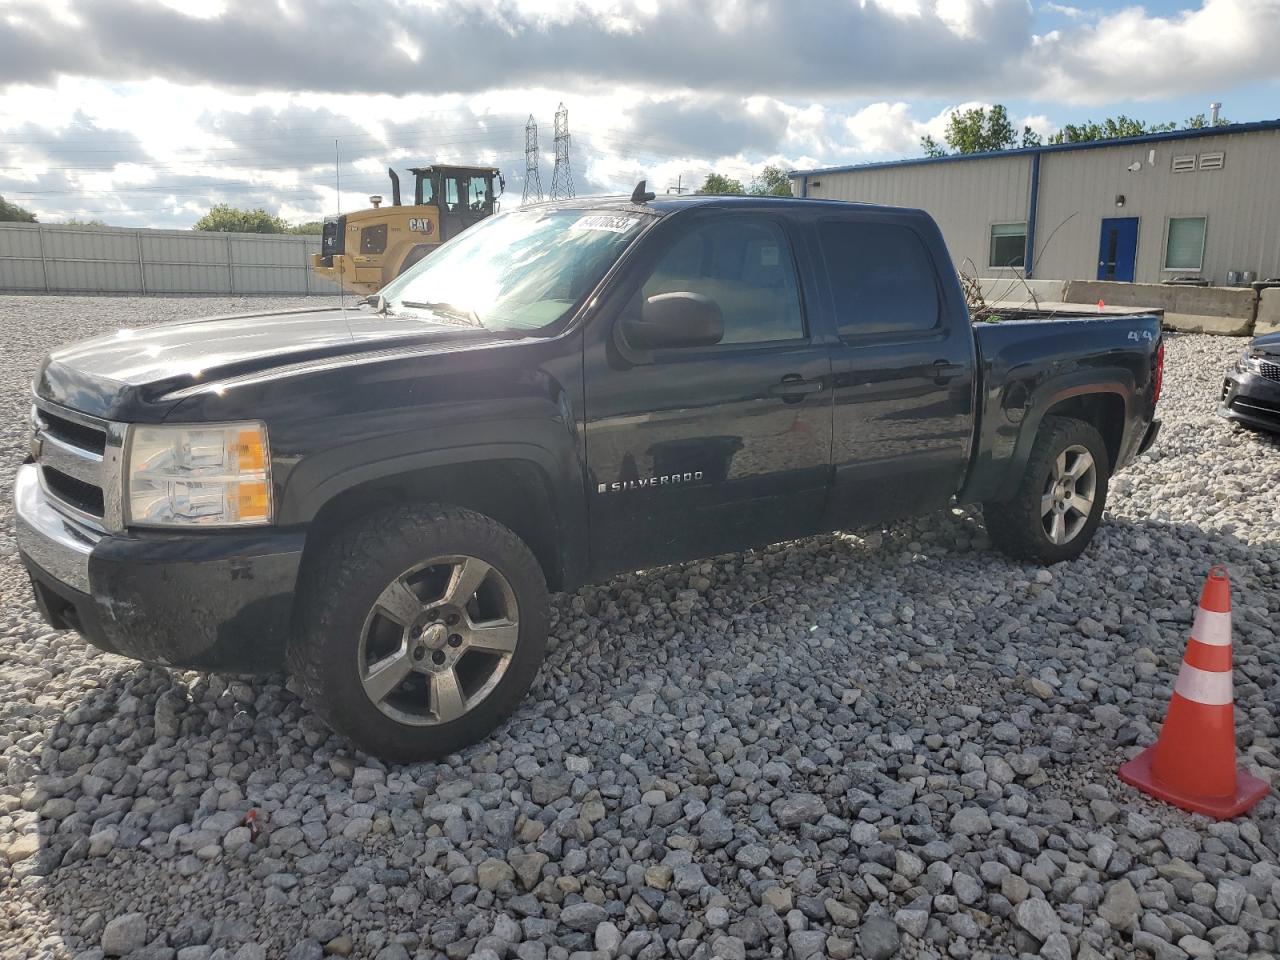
xmin=791 ymin=120 xmax=1280 ymax=284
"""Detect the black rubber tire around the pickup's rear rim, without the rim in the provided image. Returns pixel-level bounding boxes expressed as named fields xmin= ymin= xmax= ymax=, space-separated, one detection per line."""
xmin=983 ymin=416 xmax=1111 ymax=566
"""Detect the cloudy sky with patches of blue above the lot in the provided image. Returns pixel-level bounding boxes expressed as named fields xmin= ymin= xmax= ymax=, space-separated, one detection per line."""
xmin=0 ymin=0 xmax=1280 ymax=227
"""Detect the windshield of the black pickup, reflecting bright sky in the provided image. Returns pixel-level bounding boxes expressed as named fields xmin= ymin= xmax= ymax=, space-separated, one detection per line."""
xmin=381 ymin=210 xmax=645 ymax=330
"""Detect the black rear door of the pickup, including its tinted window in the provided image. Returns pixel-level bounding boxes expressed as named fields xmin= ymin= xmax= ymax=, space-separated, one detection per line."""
xmin=815 ymin=210 xmax=975 ymax=525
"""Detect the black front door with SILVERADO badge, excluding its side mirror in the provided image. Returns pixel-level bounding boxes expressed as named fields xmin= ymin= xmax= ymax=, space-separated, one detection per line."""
xmin=584 ymin=210 xmax=831 ymax=576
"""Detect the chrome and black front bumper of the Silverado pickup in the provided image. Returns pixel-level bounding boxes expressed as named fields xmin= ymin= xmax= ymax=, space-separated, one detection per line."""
xmin=14 ymin=463 xmax=303 ymax=673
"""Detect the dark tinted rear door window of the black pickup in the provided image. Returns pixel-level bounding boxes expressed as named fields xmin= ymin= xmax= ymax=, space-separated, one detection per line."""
xmin=818 ymin=220 xmax=940 ymax=337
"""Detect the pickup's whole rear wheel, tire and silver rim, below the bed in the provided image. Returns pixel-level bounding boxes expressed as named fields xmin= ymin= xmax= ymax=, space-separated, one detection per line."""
xmin=983 ymin=417 xmax=1111 ymax=564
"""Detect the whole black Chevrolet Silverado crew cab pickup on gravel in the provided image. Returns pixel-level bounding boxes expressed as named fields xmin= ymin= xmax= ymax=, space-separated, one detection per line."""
xmin=15 ymin=188 xmax=1162 ymax=760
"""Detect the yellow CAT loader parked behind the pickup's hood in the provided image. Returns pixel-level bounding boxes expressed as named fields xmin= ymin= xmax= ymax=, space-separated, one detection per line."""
xmin=311 ymin=165 xmax=507 ymax=293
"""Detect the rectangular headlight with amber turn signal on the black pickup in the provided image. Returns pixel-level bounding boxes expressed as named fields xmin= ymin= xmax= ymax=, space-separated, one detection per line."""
xmin=125 ymin=422 xmax=271 ymax=526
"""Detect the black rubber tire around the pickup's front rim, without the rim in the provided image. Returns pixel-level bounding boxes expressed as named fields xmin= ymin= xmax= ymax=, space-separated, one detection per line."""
xmin=288 ymin=503 xmax=549 ymax=763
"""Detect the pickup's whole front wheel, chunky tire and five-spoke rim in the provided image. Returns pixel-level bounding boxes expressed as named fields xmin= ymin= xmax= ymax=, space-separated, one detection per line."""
xmin=289 ymin=504 xmax=548 ymax=763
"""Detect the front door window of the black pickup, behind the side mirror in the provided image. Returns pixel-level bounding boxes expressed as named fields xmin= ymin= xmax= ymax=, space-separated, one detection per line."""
xmin=641 ymin=216 xmax=804 ymax=343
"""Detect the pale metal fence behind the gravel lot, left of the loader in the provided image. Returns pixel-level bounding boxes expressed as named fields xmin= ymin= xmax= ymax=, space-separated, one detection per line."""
xmin=0 ymin=223 xmax=338 ymax=294
